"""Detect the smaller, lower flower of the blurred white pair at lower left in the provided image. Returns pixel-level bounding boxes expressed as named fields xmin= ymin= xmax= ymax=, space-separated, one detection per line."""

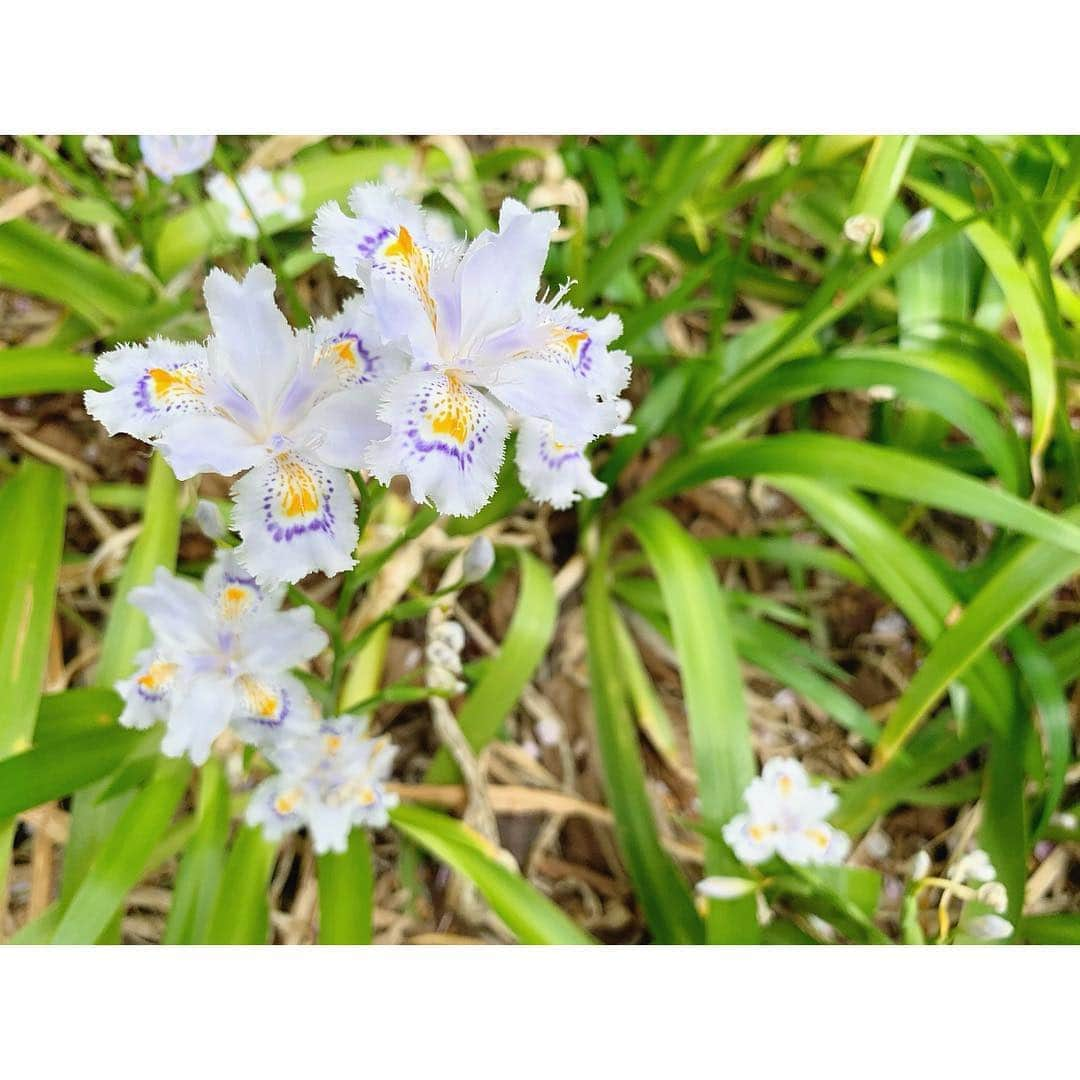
xmin=245 ymin=716 xmax=397 ymax=854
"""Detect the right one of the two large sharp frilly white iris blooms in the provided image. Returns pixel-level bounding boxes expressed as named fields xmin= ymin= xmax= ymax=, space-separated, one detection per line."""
xmin=314 ymin=185 xmax=630 ymax=515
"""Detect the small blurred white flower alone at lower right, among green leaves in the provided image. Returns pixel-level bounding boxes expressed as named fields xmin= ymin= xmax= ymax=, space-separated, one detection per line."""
xmin=724 ymin=757 xmax=851 ymax=866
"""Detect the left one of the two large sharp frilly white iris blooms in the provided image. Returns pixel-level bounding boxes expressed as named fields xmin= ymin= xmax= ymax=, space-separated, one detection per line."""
xmin=85 ymin=266 xmax=404 ymax=582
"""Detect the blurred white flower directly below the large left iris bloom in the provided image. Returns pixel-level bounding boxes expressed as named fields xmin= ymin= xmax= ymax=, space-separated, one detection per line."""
xmin=117 ymin=551 xmax=327 ymax=765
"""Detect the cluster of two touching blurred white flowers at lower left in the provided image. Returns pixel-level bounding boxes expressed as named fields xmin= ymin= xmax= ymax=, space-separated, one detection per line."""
xmin=117 ymin=548 xmax=395 ymax=852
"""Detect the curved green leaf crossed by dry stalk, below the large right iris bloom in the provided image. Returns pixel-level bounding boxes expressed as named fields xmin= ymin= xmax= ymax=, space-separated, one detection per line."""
xmin=424 ymin=550 xmax=557 ymax=784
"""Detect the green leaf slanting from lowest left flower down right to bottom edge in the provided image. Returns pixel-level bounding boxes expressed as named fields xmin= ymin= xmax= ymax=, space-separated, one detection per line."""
xmin=390 ymin=806 xmax=594 ymax=945
